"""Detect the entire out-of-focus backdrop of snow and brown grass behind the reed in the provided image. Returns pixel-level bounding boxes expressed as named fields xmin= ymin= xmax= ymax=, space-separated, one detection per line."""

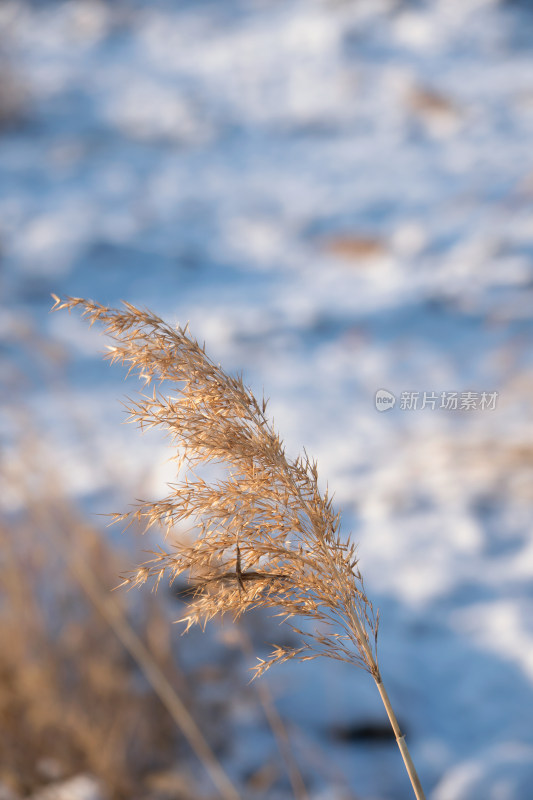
xmin=0 ymin=0 xmax=533 ymax=800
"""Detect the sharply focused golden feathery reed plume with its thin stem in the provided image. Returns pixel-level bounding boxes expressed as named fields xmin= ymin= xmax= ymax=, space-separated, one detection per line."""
xmin=54 ymin=295 xmax=424 ymax=799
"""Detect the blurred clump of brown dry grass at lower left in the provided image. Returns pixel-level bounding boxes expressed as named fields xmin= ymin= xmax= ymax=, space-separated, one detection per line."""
xmin=0 ymin=446 xmax=191 ymax=798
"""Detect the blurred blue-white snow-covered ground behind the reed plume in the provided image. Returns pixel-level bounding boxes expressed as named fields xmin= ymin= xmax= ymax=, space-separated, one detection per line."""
xmin=0 ymin=0 xmax=533 ymax=800
